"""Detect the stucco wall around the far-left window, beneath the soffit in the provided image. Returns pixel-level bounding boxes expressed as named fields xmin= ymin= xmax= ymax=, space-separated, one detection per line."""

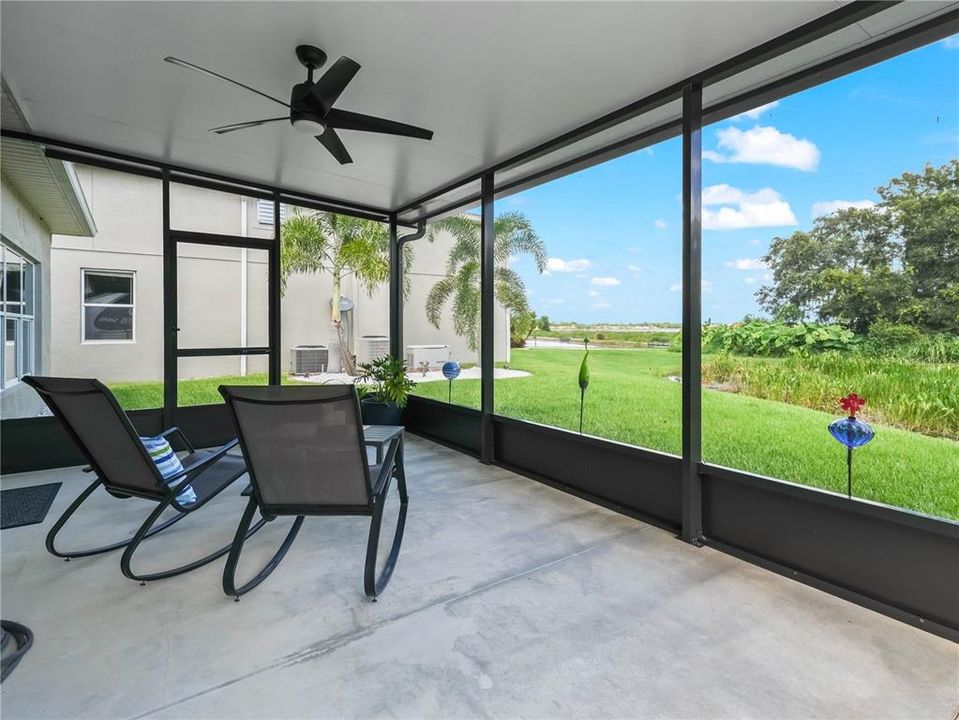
xmin=0 ymin=178 xmax=50 ymax=418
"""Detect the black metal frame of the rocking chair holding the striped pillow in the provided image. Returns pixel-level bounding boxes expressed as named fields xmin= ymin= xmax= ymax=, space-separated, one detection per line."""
xmin=23 ymin=376 xmax=266 ymax=585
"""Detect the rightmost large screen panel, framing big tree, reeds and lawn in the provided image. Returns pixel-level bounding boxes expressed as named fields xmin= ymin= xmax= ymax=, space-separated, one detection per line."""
xmin=702 ymin=42 xmax=959 ymax=521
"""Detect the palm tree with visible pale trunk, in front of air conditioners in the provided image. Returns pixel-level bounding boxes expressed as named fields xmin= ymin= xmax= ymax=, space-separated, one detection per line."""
xmin=280 ymin=209 xmax=412 ymax=372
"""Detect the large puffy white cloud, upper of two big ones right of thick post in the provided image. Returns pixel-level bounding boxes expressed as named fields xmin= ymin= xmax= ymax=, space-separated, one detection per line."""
xmin=703 ymin=125 xmax=819 ymax=172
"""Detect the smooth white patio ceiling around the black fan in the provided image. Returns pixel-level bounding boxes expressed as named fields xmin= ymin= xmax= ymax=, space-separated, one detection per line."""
xmin=0 ymin=0 xmax=921 ymax=209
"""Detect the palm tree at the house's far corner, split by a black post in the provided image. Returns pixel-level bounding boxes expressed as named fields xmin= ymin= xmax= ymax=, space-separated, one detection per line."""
xmin=426 ymin=212 xmax=546 ymax=351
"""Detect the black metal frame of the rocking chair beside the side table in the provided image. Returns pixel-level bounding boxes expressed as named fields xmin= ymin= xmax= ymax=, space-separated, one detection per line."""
xmin=220 ymin=385 xmax=409 ymax=602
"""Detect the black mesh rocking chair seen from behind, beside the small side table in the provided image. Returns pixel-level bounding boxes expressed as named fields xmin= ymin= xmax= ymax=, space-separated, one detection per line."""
xmin=220 ymin=385 xmax=409 ymax=602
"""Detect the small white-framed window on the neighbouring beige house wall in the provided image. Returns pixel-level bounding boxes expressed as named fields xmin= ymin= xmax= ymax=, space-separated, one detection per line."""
xmin=82 ymin=270 xmax=135 ymax=342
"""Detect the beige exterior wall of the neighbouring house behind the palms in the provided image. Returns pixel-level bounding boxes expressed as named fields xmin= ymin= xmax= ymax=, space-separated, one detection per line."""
xmin=46 ymin=166 xmax=509 ymax=382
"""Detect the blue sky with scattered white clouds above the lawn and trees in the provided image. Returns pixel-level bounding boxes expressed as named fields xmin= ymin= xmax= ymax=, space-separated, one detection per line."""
xmin=496 ymin=35 xmax=959 ymax=323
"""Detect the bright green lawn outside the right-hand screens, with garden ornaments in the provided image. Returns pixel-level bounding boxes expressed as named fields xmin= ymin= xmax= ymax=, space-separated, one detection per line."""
xmin=414 ymin=349 xmax=959 ymax=519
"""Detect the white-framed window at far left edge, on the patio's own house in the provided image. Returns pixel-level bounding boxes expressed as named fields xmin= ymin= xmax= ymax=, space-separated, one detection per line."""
xmin=0 ymin=245 xmax=36 ymax=388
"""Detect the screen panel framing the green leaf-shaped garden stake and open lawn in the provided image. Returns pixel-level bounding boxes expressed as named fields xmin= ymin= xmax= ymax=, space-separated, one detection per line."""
xmin=494 ymin=129 xmax=682 ymax=454
